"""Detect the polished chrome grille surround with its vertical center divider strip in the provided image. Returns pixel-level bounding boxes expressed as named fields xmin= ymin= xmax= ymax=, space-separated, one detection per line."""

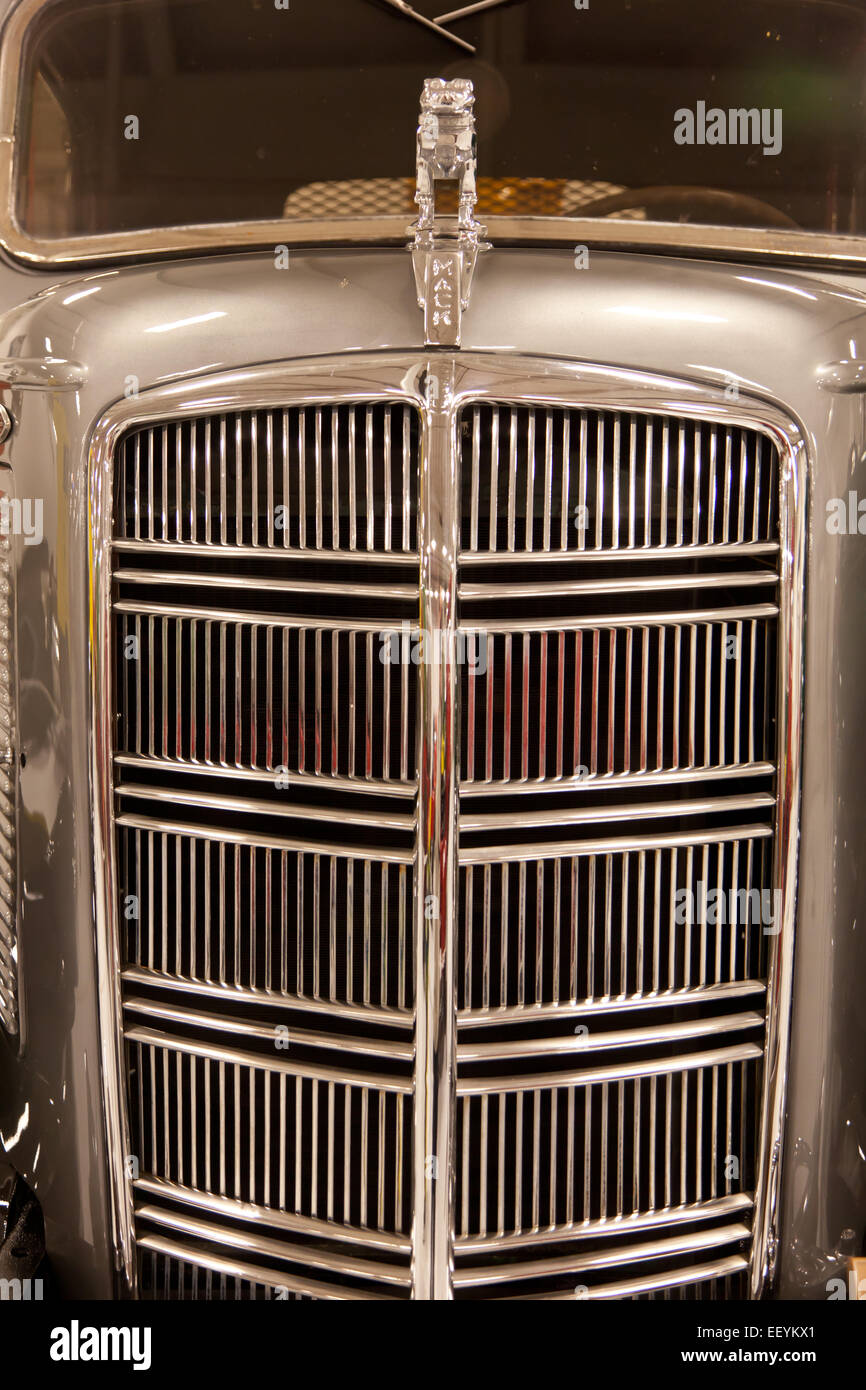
xmin=88 ymin=350 xmax=808 ymax=1298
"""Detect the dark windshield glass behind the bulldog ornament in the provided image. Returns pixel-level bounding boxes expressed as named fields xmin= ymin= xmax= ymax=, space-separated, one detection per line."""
xmin=14 ymin=0 xmax=866 ymax=238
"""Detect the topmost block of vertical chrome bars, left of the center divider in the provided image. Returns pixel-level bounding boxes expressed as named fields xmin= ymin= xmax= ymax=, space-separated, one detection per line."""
xmin=117 ymin=402 xmax=418 ymax=557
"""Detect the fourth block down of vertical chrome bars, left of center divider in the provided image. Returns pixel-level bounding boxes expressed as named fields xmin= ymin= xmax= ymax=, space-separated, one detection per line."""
xmin=126 ymin=1028 xmax=411 ymax=1237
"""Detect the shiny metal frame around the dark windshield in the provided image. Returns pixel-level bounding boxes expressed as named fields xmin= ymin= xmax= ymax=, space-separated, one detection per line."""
xmin=0 ymin=0 xmax=866 ymax=271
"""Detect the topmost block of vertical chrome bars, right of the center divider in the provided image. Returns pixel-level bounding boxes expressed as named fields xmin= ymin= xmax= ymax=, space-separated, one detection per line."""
xmin=460 ymin=402 xmax=778 ymax=559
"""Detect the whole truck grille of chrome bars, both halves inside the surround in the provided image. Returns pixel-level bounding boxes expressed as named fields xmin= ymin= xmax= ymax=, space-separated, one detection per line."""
xmin=96 ymin=353 xmax=806 ymax=1300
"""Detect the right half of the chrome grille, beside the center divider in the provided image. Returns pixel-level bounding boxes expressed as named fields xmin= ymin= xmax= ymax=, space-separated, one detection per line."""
xmin=455 ymin=402 xmax=795 ymax=1298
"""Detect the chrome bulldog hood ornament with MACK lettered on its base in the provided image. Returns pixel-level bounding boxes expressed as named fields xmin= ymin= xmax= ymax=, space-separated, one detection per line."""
xmin=410 ymin=78 xmax=488 ymax=348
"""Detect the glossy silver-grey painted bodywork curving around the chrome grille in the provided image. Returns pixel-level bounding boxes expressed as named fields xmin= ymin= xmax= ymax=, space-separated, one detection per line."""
xmin=0 ymin=250 xmax=866 ymax=1297
